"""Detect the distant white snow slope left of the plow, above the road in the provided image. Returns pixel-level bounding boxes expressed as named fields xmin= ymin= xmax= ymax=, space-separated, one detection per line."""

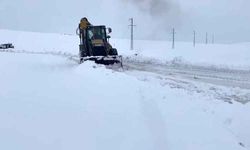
xmin=0 ymin=30 xmax=79 ymax=53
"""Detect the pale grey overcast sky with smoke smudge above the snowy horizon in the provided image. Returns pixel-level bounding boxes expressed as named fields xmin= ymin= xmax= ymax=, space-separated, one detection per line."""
xmin=0 ymin=0 xmax=250 ymax=42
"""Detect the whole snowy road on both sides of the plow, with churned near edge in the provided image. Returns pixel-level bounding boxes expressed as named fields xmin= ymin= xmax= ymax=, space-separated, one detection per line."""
xmin=0 ymin=50 xmax=250 ymax=104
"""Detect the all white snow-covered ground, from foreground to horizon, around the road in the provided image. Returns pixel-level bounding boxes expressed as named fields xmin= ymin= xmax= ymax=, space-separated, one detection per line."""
xmin=0 ymin=30 xmax=250 ymax=150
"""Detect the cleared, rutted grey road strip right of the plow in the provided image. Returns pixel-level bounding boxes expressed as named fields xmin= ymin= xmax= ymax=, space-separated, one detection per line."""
xmin=123 ymin=60 xmax=250 ymax=90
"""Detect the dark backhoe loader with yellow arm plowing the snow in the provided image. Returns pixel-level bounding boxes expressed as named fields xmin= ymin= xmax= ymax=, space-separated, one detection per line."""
xmin=77 ymin=17 xmax=122 ymax=65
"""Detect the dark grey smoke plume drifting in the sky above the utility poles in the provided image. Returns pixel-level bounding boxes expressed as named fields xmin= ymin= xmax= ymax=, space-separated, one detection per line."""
xmin=121 ymin=0 xmax=181 ymax=39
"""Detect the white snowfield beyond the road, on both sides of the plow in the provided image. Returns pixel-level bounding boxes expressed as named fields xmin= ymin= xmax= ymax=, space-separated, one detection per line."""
xmin=0 ymin=30 xmax=250 ymax=71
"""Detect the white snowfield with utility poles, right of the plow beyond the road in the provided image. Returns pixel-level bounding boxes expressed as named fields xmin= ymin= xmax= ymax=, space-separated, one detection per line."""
xmin=112 ymin=40 xmax=250 ymax=70
